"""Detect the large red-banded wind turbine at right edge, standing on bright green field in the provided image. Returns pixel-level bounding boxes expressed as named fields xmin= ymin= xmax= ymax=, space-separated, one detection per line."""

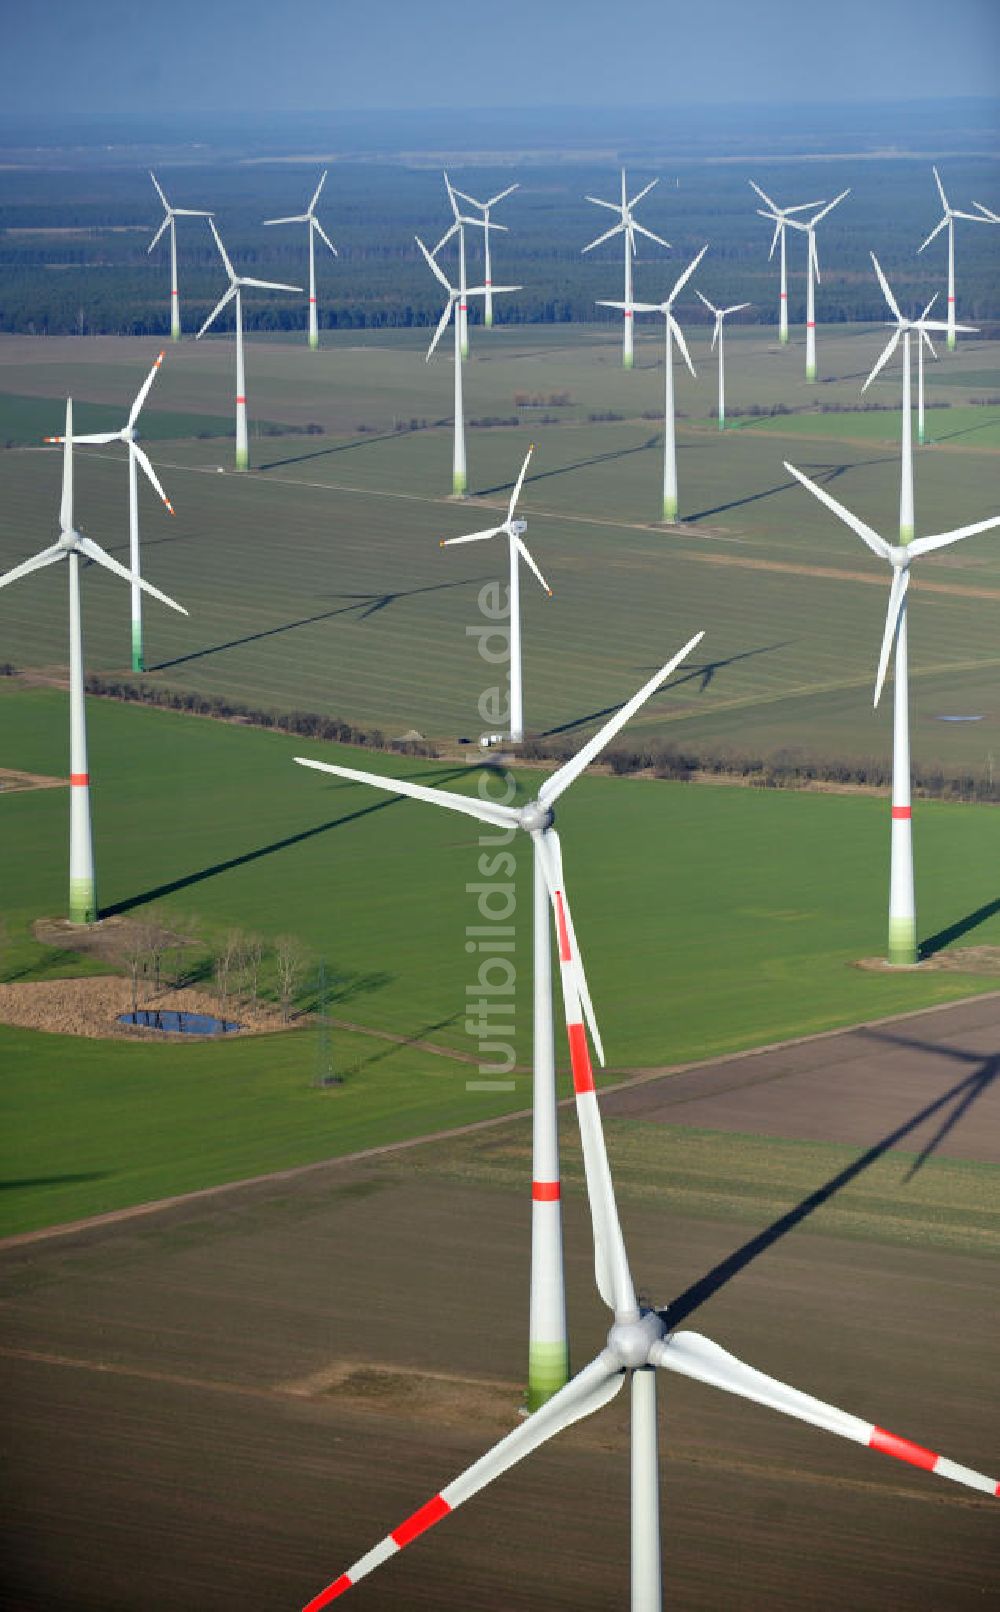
xmin=785 ymin=467 xmax=1000 ymax=967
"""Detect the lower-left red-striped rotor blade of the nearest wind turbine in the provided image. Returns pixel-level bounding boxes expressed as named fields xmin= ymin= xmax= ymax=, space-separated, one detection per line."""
xmin=303 ymin=1349 xmax=624 ymax=1612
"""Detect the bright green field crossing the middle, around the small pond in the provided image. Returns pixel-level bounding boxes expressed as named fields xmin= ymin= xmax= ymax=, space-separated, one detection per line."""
xmin=0 ymin=680 xmax=1000 ymax=1227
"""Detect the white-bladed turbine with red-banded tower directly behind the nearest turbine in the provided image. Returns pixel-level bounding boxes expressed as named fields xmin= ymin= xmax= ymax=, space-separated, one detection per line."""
xmin=295 ymin=632 xmax=703 ymax=1411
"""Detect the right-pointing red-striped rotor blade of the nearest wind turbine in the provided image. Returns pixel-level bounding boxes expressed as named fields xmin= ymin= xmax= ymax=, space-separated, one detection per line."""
xmin=650 ymin=1332 xmax=1000 ymax=1496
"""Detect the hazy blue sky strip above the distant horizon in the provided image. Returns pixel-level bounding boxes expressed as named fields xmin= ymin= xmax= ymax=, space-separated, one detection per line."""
xmin=0 ymin=0 xmax=1000 ymax=118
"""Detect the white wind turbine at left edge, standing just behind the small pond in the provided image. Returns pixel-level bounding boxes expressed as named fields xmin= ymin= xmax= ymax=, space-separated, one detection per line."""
xmin=0 ymin=398 xmax=187 ymax=924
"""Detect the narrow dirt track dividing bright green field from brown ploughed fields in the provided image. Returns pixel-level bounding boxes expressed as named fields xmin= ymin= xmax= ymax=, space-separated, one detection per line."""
xmin=0 ymin=990 xmax=1000 ymax=1254
